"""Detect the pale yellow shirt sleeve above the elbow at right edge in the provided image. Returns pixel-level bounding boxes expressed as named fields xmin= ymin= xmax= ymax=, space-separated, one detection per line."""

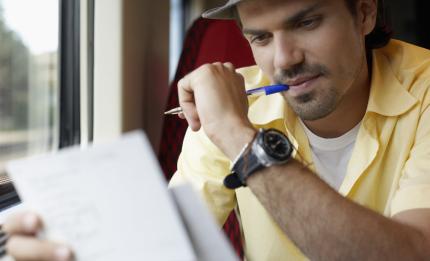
xmin=391 ymin=99 xmax=430 ymax=216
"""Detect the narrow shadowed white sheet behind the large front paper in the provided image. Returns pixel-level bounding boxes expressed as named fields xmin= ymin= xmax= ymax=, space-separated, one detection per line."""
xmin=170 ymin=185 xmax=238 ymax=261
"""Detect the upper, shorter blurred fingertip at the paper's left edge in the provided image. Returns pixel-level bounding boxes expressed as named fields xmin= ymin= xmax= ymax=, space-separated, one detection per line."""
xmin=3 ymin=213 xmax=42 ymax=235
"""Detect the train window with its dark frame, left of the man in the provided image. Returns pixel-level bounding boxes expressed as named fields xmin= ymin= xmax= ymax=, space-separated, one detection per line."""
xmin=0 ymin=0 xmax=85 ymax=210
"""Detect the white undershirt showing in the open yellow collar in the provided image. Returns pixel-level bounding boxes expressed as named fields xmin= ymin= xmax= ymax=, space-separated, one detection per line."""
xmin=302 ymin=119 xmax=361 ymax=190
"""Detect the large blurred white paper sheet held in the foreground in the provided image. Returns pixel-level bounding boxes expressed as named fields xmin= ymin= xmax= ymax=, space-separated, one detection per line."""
xmin=7 ymin=132 xmax=196 ymax=261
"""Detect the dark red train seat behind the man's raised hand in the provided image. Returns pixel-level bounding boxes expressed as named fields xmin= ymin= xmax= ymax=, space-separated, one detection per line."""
xmin=158 ymin=18 xmax=255 ymax=258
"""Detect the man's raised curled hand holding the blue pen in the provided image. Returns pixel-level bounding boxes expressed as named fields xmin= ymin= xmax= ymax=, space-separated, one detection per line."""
xmin=178 ymin=63 xmax=256 ymax=159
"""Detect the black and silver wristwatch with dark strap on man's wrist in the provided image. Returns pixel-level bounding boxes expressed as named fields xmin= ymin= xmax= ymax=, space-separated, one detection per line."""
xmin=224 ymin=129 xmax=293 ymax=189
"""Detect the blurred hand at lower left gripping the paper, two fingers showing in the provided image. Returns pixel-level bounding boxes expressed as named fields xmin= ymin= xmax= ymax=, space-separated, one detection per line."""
xmin=3 ymin=213 xmax=73 ymax=261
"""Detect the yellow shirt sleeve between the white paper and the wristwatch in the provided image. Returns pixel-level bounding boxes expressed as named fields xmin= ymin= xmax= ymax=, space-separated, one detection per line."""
xmin=169 ymin=129 xmax=236 ymax=226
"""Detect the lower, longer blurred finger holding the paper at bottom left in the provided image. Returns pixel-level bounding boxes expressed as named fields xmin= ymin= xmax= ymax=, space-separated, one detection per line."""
xmin=6 ymin=236 xmax=73 ymax=261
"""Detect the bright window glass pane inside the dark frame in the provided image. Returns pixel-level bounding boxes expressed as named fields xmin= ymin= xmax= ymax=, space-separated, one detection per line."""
xmin=0 ymin=0 xmax=59 ymax=173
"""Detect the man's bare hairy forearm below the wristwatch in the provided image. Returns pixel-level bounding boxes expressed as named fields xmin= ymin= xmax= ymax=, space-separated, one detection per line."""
xmin=247 ymin=160 xmax=428 ymax=260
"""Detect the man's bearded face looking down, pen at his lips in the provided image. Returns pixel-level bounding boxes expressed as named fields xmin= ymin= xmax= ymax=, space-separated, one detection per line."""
xmin=238 ymin=0 xmax=373 ymax=120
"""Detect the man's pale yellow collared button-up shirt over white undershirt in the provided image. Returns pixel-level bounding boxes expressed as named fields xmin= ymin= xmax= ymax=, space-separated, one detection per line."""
xmin=171 ymin=40 xmax=430 ymax=261
